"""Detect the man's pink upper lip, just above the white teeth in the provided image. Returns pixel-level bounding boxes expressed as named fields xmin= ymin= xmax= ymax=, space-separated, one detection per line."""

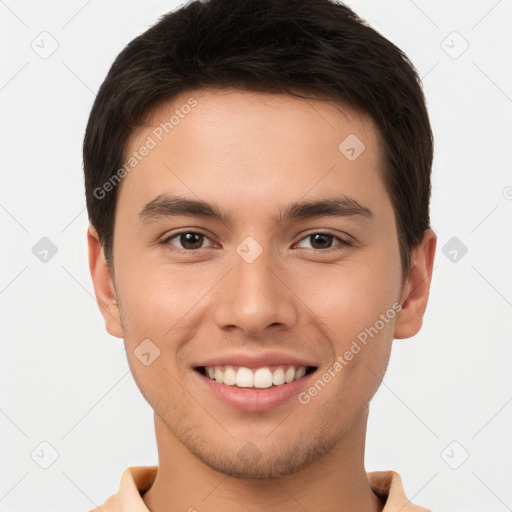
xmin=192 ymin=352 xmax=316 ymax=368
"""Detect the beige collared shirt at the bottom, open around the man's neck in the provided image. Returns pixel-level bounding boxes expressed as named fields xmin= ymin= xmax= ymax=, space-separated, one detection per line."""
xmin=90 ymin=466 xmax=432 ymax=512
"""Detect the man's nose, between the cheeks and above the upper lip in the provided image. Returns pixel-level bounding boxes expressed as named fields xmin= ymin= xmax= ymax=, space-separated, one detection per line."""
xmin=214 ymin=246 xmax=298 ymax=337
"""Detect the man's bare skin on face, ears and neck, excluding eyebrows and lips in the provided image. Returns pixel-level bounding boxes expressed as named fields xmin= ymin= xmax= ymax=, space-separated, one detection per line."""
xmin=88 ymin=89 xmax=436 ymax=512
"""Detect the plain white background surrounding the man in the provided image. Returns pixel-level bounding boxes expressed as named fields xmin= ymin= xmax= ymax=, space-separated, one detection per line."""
xmin=0 ymin=0 xmax=512 ymax=512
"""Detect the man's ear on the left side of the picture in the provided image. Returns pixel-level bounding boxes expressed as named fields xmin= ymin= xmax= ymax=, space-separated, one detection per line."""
xmin=87 ymin=226 xmax=123 ymax=338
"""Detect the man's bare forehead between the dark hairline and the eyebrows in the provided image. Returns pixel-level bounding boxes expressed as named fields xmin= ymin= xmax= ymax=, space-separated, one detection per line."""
xmin=118 ymin=89 xmax=385 ymax=222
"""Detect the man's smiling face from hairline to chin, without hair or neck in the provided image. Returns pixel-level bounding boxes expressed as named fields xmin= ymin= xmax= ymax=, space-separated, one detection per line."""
xmin=91 ymin=90 xmax=434 ymax=478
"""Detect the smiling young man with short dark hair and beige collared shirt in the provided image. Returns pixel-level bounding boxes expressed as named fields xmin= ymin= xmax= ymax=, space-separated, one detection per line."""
xmin=84 ymin=0 xmax=436 ymax=512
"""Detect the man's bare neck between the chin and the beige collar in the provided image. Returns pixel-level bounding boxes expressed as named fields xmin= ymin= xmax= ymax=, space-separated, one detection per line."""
xmin=142 ymin=409 xmax=383 ymax=512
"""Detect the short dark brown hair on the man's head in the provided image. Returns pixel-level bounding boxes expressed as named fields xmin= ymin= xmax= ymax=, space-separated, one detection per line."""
xmin=83 ymin=0 xmax=433 ymax=274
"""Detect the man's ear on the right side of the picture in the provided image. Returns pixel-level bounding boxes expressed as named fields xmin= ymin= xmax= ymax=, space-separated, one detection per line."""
xmin=394 ymin=229 xmax=437 ymax=339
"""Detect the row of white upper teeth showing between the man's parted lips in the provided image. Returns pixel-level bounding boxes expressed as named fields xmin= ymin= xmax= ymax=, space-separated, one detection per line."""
xmin=195 ymin=365 xmax=317 ymax=389
